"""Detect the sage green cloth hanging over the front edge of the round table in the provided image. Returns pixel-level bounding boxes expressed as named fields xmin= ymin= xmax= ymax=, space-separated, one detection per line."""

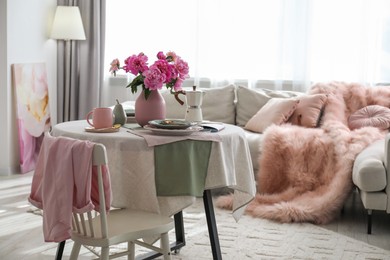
xmin=154 ymin=140 xmax=211 ymax=197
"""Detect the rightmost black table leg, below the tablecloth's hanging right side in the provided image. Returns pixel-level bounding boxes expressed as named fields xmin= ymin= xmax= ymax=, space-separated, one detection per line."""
xmin=203 ymin=190 xmax=222 ymax=260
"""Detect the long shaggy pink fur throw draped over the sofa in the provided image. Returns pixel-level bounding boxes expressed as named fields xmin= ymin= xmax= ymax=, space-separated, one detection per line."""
xmin=216 ymin=82 xmax=390 ymax=223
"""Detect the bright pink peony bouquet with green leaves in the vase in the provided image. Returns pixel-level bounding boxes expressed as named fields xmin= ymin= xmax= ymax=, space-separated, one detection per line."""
xmin=110 ymin=51 xmax=189 ymax=99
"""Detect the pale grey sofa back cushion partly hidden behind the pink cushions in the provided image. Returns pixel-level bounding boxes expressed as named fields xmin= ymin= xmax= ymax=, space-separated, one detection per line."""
xmin=236 ymin=86 xmax=304 ymax=126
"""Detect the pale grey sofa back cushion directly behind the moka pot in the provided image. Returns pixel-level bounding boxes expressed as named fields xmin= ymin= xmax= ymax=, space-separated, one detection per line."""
xmin=162 ymin=85 xmax=235 ymax=124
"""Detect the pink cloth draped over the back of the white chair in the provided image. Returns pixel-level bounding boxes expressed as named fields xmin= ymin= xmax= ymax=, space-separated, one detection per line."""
xmin=28 ymin=134 xmax=111 ymax=242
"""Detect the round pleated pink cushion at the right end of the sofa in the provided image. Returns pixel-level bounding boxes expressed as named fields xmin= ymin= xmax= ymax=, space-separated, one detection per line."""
xmin=348 ymin=105 xmax=390 ymax=130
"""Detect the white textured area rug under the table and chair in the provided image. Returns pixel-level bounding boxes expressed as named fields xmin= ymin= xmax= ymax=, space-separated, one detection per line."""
xmin=22 ymin=199 xmax=390 ymax=260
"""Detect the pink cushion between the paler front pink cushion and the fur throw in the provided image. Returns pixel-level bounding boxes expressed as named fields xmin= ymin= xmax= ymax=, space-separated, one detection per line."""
xmin=288 ymin=94 xmax=328 ymax=128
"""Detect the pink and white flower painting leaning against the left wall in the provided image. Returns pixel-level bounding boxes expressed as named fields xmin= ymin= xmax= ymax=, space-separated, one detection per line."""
xmin=12 ymin=63 xmax=50 ymax=173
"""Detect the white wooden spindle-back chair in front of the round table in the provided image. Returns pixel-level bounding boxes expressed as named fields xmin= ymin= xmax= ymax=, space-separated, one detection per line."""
xmin=70 ymin=144 xmax=174 ymax=259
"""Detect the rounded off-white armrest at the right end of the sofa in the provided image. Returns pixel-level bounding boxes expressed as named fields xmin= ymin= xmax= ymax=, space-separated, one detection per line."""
xmin=352 ymin=139 xmax=387 ymax=192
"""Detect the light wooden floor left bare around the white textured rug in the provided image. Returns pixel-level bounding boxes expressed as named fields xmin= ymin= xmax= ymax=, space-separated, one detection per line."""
xmin=0 ymin=174 xmax=390 ymax=259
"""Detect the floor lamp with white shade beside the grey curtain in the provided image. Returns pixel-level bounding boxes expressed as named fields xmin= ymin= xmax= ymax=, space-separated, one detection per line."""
xmin=51 ymin=6 xmax=86 ymax=121
